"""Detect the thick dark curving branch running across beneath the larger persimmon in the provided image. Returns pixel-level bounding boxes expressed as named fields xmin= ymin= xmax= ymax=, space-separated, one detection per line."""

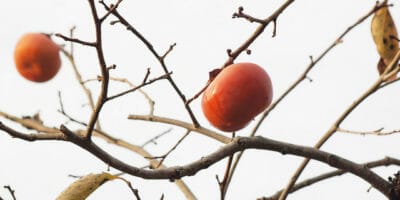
xmin=0 ymin=115 xmax=399 ymax=199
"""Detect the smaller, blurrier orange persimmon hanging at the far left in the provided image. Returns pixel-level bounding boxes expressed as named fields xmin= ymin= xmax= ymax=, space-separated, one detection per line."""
xmin=14 ymin=33 xmax=61 ymax=82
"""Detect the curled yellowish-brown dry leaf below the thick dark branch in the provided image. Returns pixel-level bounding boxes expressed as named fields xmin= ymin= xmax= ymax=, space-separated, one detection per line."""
xmin=57 ymin=172 xmax=119 ymax=200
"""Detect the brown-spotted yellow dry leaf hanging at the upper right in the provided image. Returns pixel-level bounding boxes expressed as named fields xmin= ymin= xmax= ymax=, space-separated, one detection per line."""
xmin=371 ymin=6 xmax=399 ymax=81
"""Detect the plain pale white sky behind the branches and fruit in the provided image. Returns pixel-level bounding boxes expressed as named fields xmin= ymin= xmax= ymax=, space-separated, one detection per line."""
xmin=0 ymin=0 xmax=400 ymax=200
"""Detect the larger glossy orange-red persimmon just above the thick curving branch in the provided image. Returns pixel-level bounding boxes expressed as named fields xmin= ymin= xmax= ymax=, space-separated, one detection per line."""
xmin=201 ymin=63 xmax=273 ymax=132
